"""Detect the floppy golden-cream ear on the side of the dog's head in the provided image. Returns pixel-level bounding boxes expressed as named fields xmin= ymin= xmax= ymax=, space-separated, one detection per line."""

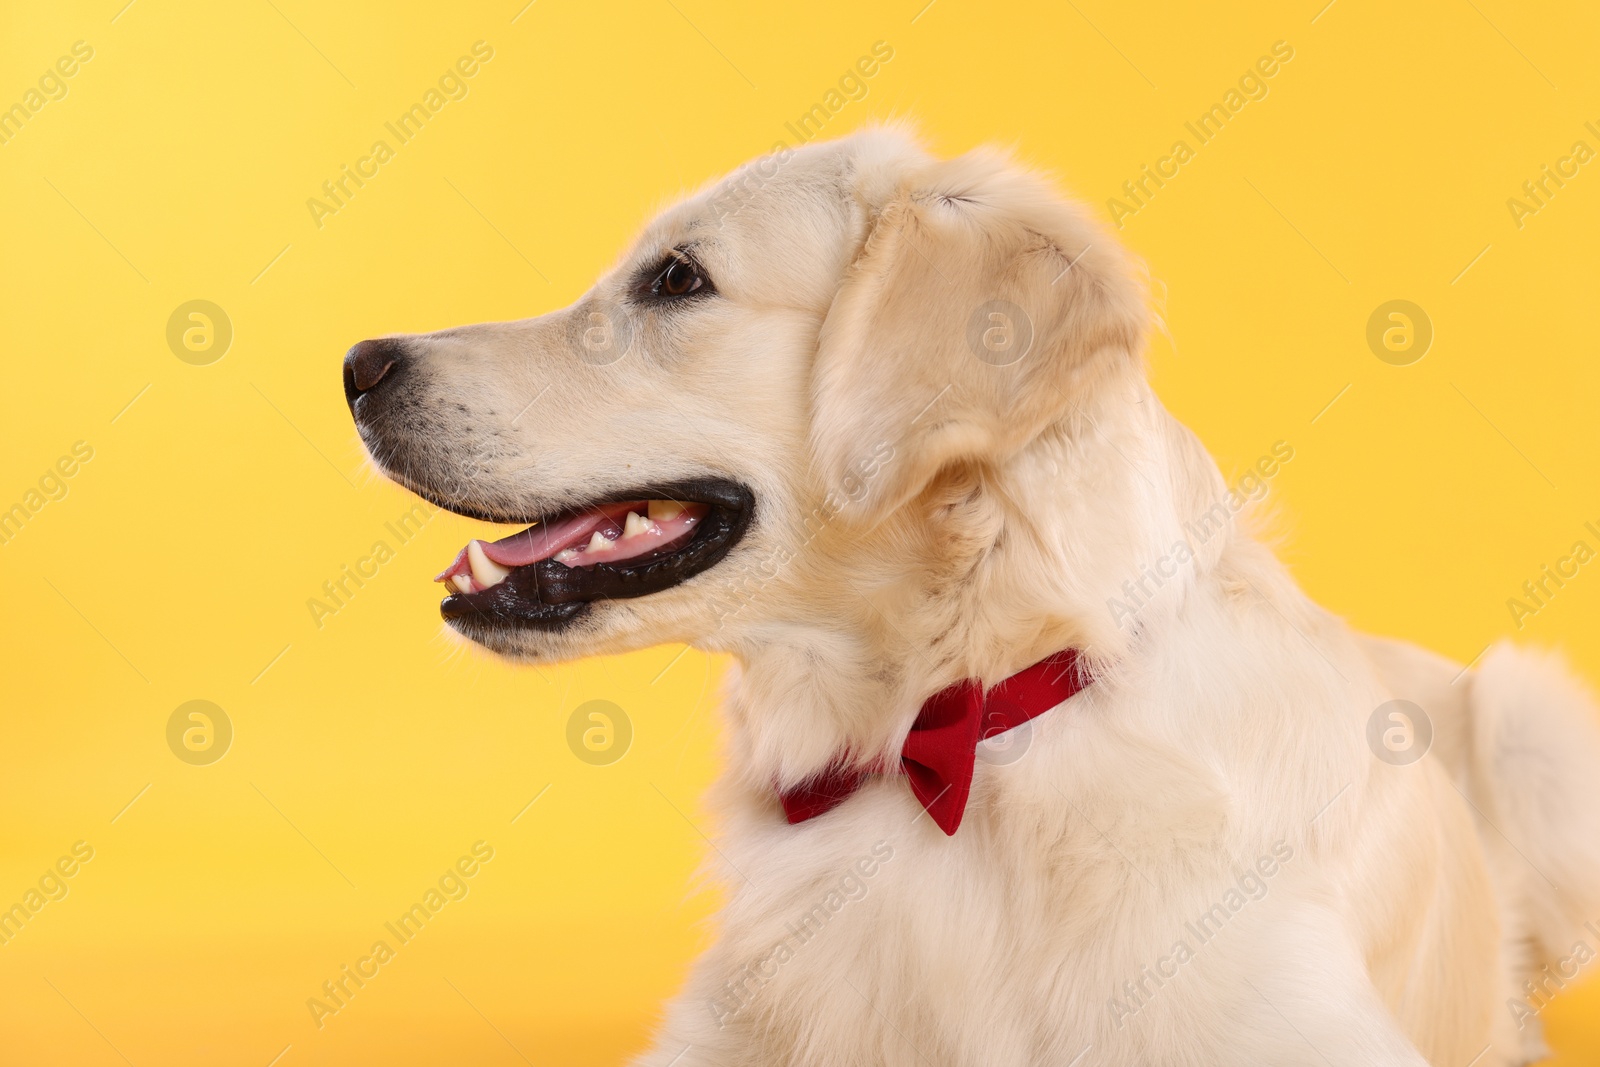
xmin=811 ymin=152 xmax=1147 ymax=525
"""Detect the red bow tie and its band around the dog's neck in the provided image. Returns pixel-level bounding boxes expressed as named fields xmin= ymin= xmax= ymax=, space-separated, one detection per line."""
xmin=778 ymin=648 xmax=1090 ymax=835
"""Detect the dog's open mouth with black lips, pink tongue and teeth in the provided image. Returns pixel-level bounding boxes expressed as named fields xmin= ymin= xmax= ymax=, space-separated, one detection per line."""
xmin=435 ymin=478 xmax=755 ymax=629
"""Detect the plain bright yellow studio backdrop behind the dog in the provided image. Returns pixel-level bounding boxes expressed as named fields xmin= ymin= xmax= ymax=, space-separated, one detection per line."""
xmin=0 ymin=0 xmax=1600 ymax=1067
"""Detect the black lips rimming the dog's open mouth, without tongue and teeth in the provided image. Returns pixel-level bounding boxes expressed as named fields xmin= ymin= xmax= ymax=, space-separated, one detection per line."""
xmin=434 ymin=478 xmax=755 ymax=637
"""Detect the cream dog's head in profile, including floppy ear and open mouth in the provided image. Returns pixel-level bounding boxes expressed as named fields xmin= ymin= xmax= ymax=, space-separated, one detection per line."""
xmin=344 ymin=130 xmax=1146 ymax=659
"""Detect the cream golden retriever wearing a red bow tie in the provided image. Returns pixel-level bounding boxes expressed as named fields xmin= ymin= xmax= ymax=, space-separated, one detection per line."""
xmin=344 ymin=126 xmax=1600 ymax=1067
